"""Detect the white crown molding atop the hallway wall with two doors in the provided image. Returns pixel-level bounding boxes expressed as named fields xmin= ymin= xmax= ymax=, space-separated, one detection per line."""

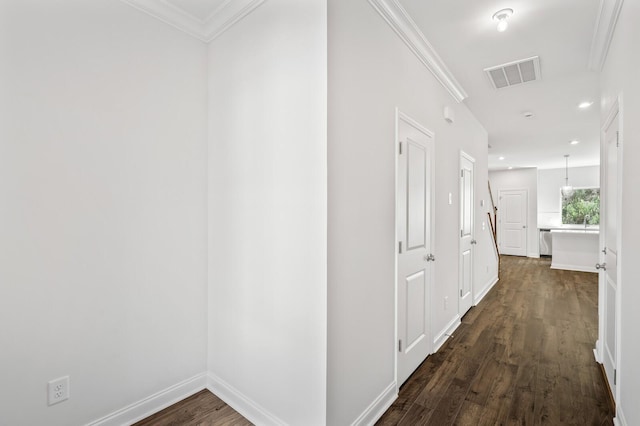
xmin=369 ymin=0 xmax=467 ymax=102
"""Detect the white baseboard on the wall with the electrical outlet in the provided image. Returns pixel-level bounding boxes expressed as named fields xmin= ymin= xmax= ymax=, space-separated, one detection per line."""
xmin=87 ymin=373 xmax=207 ymax=426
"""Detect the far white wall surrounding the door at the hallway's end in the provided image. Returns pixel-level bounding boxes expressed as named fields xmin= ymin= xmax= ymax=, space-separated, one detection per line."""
xmin=489 ymin=168 xmax=540 ymax=257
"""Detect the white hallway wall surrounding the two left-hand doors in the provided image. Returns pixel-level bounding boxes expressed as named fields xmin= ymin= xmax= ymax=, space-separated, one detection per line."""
xmin=327 ymin=0 xmax=495 ymax=425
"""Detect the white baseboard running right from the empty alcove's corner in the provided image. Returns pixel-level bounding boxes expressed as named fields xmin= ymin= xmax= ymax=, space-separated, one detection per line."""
xmin=207 ymin=372 xmax=286 ymax=426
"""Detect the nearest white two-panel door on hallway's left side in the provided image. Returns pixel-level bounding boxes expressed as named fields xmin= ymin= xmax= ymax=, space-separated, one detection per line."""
xmin=396 ymin=113 xmax=435 ymax=386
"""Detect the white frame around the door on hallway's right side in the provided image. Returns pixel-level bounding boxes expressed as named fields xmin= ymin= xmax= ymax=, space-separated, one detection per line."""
xmin=594 ymin=93 xmax=624 ymax=410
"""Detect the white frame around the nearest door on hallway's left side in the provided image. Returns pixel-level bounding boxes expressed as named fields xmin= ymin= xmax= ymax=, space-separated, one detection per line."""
xmin=392 ymin=107 xmax=436 ymax=395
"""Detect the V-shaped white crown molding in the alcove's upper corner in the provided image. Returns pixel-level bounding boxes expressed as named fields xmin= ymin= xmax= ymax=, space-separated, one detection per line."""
xmin=121 ymin=0 xmax=266 ymax=43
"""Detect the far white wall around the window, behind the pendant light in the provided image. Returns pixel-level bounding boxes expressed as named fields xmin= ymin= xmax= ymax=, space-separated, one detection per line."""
xmin=538 ymin=166 xmax=600 ymax=228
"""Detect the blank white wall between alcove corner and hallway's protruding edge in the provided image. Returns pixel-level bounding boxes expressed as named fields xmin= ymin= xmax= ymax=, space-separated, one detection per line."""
xmin=209 ymin=0 xmax=327 ymax=425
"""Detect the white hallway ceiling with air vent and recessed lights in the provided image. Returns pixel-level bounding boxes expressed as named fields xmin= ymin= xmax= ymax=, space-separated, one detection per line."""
xmin=401 ymin=0 xmax=599 ymax=170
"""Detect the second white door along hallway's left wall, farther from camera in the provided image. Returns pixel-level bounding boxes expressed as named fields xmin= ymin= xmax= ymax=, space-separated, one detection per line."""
xmin=458 ymin=152 xmax=476 ymax=316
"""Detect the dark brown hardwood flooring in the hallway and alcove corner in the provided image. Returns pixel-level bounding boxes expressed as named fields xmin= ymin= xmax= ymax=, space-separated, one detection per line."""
xmin=136 ymin=256 xmax=613 ymax=426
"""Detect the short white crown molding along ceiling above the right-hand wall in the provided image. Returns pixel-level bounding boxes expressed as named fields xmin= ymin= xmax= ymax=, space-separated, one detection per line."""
xmin=589 ymin=0 xmax=624 ymax=72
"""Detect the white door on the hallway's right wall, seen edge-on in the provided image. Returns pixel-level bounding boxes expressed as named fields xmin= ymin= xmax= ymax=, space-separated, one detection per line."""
xmin=596 ymin=108 xmax=620 ymax=396
